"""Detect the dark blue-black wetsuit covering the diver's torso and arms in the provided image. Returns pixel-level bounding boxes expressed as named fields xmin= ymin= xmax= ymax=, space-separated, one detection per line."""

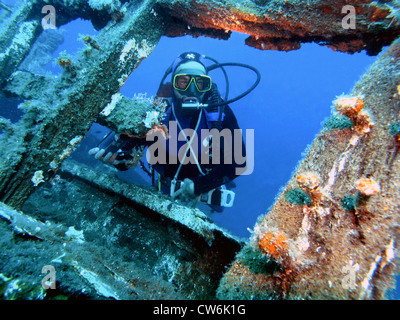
xmin=116 ymin=84 xmax=246 ymax=195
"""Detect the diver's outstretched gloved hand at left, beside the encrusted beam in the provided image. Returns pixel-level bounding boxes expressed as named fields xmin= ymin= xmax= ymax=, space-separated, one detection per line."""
xmin=89 ymin=132 xmax=144 ymax=171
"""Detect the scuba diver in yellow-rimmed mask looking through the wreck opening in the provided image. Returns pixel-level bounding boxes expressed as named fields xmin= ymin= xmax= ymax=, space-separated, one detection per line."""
xmin=89 ymin=52 xmax=260 ymax=212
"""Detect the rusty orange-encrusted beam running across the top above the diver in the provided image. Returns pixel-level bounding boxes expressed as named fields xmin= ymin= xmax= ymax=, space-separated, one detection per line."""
xmin=157 ymin=0 xmax=400 ymax=55
